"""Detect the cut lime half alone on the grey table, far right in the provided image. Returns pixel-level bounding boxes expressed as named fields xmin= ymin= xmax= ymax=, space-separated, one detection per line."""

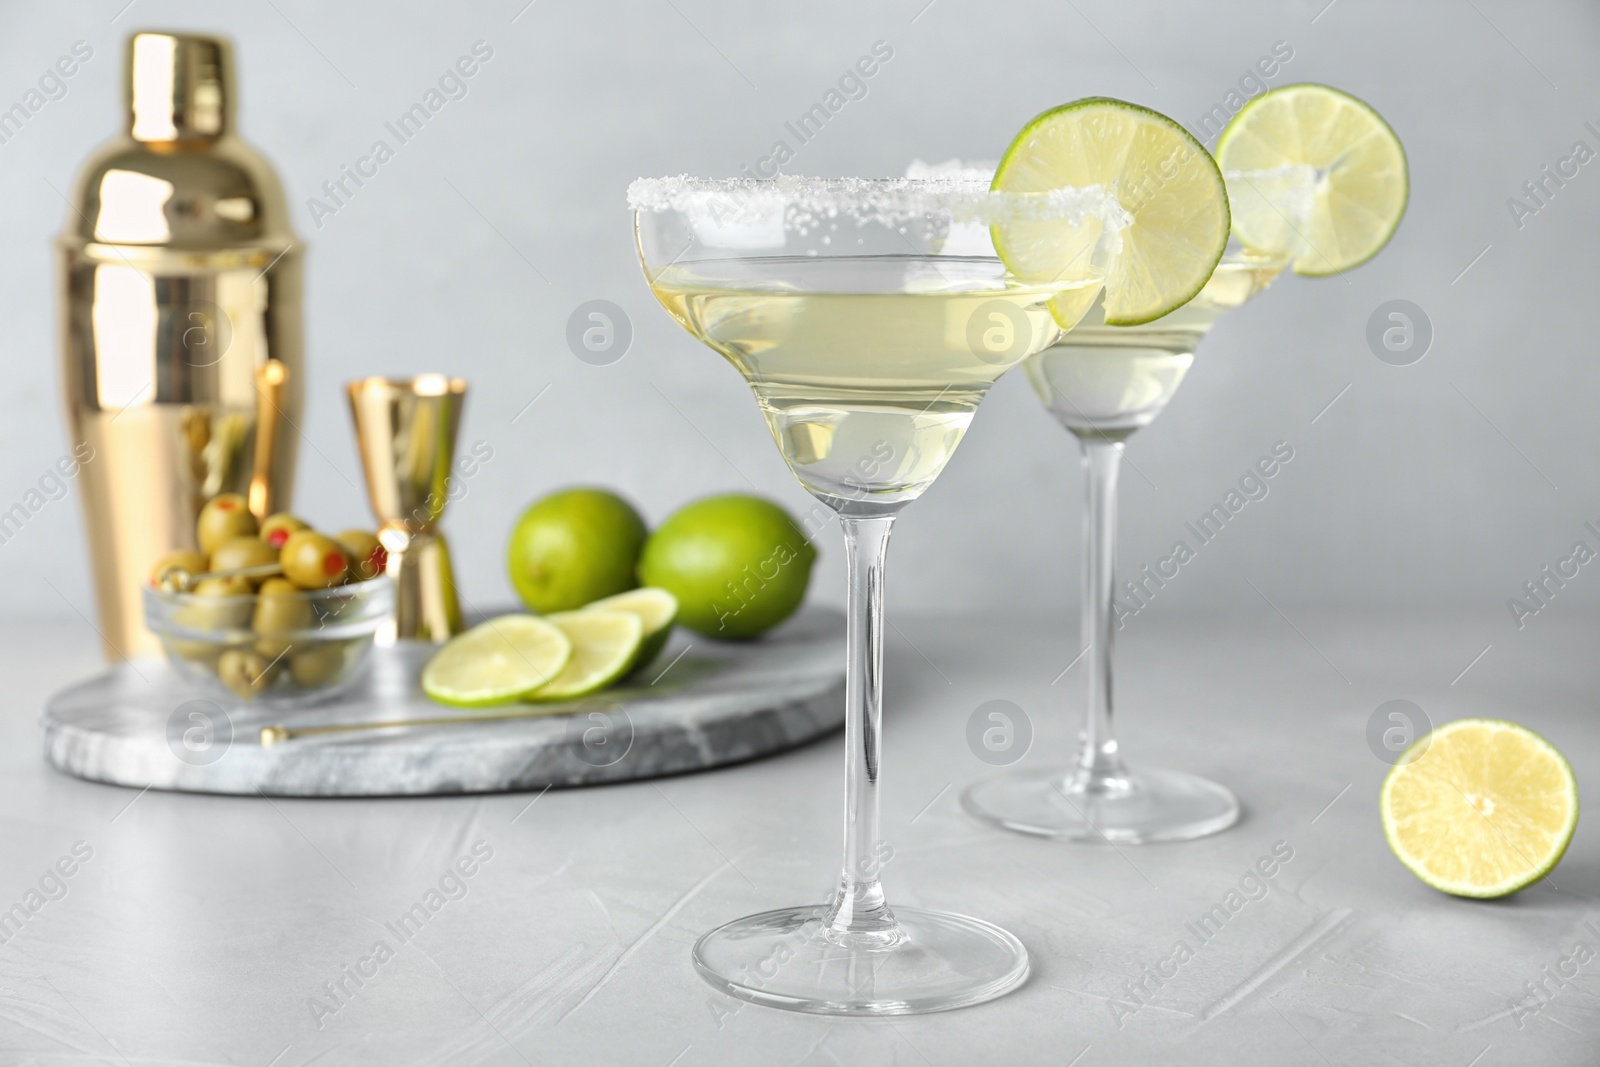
xmin=1379 ymin=718 xmax=1578 ymax=897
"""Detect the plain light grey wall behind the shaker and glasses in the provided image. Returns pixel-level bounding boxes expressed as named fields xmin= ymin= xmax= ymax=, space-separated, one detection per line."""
xmin=0 ymin=0 xmax=1600 ymax=643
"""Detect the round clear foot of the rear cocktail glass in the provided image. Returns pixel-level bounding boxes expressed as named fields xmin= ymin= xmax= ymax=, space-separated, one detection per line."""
xmin=962 ymin=769 xmax=1238 ymax=845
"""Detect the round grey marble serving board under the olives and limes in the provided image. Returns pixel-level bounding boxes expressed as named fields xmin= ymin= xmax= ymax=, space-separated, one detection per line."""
xmin=42 ymin=608 xmax=845 ymax=797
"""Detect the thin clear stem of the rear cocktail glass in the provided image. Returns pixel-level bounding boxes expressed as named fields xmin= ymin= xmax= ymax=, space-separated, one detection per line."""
xmin=1067 ymin=437 xmax=1130 ymax=793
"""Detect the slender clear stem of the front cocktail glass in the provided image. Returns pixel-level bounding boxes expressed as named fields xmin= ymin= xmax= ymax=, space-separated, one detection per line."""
xmin=827 ymin=515 xmax=901 ymax=945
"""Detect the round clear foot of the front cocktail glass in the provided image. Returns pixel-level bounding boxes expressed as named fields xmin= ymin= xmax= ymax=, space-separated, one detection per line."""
xmin=694 ymin=904 xmax=1027 ymax=1016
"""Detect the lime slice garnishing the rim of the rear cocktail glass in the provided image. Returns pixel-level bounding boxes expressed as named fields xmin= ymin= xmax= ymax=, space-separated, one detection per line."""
xmin=1216 ymin=85 xmax=1410 ymax=275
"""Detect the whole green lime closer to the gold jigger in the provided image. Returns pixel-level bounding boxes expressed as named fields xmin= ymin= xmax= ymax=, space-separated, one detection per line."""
xmin=506 ymin=488 xmax=650 ymax=614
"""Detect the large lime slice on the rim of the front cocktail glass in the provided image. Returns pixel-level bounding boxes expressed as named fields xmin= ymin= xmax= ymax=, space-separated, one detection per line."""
xmin=990 ymin=96 xmax=1229 ymax=326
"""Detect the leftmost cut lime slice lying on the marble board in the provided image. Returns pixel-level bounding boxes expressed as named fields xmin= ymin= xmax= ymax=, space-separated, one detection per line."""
xmin=422 ymin=614 xmax=573 ymax=707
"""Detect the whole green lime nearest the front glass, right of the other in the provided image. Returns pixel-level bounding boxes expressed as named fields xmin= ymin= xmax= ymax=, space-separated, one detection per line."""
xmin=638 ymin=494 xmax=816 ymax=640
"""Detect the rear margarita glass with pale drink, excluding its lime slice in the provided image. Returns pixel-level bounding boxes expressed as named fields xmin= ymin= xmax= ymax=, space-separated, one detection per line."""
xmin=962 ymin=245 xmax=1288 ymax=845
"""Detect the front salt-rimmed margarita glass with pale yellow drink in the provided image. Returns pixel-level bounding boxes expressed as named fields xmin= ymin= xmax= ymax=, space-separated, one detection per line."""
xmin=629 ymin=178 xmax=1099 ymax=1016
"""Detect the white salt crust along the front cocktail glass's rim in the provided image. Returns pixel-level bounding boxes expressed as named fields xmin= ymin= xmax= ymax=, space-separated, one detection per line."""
xmin=627 ymin=174 xmax=1126 ymax=227
